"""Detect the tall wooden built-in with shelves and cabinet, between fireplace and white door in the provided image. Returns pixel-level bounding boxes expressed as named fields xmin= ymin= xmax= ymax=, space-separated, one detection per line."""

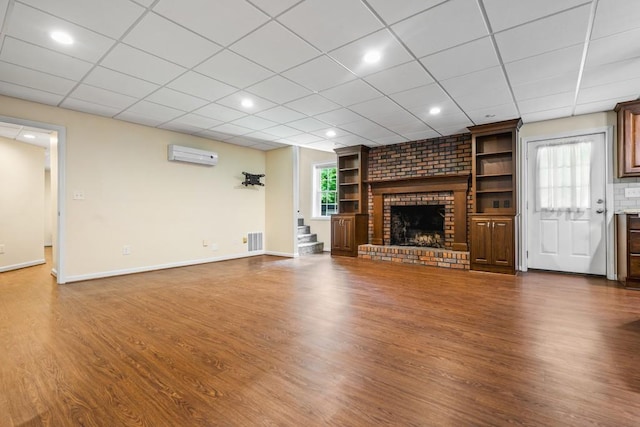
xmin=469 ymin=119 xmax=522 ymax=274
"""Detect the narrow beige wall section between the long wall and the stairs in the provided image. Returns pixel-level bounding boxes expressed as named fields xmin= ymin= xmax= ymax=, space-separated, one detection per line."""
xmin=264 ymin=147 xmax=297 ymax=256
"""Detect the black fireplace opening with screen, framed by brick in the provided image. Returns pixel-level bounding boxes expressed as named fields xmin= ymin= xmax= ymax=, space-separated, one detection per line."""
xmin=391 ymin=205 xmax=445 ymax=248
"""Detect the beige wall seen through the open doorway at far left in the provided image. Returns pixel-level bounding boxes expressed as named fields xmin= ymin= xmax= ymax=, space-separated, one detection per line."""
xmin=0 ymin=137 xmax=44 ymax=271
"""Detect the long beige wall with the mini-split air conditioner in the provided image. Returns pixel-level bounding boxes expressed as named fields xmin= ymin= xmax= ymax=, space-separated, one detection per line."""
xmin=0 ymin=97 xmax=265 ymax=281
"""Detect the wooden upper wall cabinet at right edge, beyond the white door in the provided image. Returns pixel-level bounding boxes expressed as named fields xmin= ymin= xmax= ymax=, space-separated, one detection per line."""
xmin=615 ymin=101 xmax=640 ymax=178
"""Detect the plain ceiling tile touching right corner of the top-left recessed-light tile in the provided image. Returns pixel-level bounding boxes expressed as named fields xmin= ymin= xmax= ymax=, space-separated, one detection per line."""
xmin=123 ymin=13 xmax=221 ymax=68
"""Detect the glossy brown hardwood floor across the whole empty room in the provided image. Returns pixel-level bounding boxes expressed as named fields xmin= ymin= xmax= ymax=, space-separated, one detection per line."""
xmin=0 ymin=251 xmax=640 ymax=426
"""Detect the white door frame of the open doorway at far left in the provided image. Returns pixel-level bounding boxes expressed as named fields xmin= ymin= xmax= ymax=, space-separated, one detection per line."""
xmin=0 ymin=115 xmax=67 ymax=284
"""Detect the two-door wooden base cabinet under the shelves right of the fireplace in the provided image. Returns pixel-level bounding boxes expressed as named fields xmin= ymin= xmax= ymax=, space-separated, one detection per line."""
xmin=471 ymin=215 xmax=515 ymax=274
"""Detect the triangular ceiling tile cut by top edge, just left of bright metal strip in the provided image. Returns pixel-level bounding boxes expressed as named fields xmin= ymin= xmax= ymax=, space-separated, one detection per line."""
xmin=484 ymin=0 xmax=590 ymax=33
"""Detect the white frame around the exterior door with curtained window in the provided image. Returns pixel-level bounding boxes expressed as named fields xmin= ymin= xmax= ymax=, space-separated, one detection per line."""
xmin=517 ymin=126 xmax=616 ymax=280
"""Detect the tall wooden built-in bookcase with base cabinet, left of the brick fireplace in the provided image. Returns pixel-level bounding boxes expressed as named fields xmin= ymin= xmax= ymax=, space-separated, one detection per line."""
xmin=331 ymin=145 xmax=369 ymax=257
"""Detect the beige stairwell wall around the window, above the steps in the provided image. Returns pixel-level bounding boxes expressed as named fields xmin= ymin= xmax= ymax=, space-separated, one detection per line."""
xmin=298 ymin=148 xmax=336 ymax=251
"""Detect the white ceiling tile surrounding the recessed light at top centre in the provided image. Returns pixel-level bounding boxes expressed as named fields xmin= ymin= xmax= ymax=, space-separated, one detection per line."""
xmin=329 ymin=29 xmax=413 ymax=77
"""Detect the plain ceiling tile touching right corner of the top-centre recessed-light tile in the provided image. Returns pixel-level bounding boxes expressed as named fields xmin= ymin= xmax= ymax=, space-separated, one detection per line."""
xmin=420 ymin=37 xmax=500 ymax=80
